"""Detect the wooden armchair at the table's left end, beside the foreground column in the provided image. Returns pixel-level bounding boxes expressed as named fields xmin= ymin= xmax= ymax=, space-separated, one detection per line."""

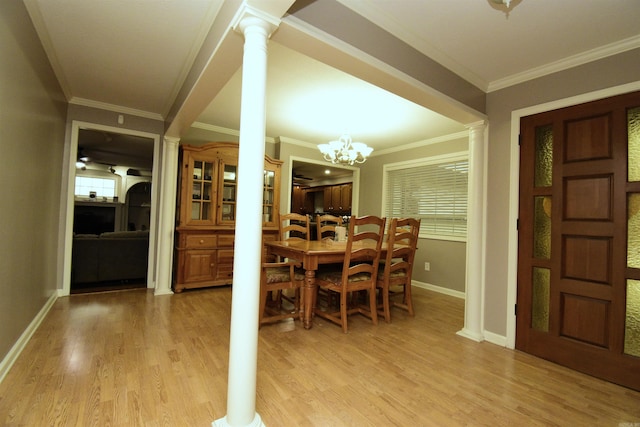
xmin=259 ymin=260 xmax=304 ymax=326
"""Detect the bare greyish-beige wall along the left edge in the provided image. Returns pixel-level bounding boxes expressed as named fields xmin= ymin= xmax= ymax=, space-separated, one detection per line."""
xmin=0 ymin=1 xmax=66 ymax=362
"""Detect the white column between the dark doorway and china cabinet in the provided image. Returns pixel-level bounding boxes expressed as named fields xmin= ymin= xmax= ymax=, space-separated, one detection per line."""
xmin=154 ymin=136 xmax=180 ymax=295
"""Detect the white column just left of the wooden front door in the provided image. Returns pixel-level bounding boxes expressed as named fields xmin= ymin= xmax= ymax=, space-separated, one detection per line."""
xmin=458 ymin=121 xmax=486 ymax=341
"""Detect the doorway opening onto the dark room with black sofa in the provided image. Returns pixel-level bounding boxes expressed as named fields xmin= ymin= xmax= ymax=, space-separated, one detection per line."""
xmin=63 ymin=122 xmax=159 ymax=294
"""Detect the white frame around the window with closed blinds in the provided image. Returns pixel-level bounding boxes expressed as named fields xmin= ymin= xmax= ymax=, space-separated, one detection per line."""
xmin=382 ymin=151 xmax=469 ymax=242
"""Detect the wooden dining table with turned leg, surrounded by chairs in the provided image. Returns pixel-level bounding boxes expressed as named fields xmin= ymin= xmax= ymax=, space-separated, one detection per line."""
xmin=264 ymin=239 xmax=387 ymax=329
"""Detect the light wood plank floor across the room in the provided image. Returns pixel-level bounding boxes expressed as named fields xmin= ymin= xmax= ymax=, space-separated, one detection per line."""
xmin=0 ymin=288 xmax=640 ymax=427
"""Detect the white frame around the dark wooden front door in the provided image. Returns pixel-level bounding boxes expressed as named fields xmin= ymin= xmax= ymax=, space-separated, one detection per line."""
xmin=506 ymin=81 xmax=640 ymax=349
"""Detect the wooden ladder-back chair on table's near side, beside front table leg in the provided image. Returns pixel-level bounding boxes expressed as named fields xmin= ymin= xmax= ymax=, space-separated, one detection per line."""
xmin=315 ymin=215 xmax=386 ymax=333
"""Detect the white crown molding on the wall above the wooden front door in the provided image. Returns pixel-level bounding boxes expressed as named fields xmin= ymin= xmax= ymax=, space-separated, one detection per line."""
xmin=487 ymin=36 xmax=640 ymax=93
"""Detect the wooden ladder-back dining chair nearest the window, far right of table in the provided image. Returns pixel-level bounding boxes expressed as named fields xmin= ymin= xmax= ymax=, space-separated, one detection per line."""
xmin=376 ymin=218 xmax=420 ymax=323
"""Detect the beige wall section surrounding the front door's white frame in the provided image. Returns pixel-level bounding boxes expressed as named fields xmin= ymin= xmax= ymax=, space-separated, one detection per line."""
xmin=484 ymin=49 xmax=640 ymax=335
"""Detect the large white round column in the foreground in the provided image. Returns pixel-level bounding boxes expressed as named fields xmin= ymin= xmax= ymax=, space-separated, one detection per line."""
xmin=213 ymin=11 xmax=278 ymax=427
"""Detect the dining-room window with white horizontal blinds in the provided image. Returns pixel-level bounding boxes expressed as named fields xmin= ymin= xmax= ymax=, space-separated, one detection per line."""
xmin=383 ymin=152 xmax=469 ymax=241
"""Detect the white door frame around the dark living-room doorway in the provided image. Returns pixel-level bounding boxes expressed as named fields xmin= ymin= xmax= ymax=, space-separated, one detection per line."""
xmin=58 ymin=120 xmax=160 ymax=296
